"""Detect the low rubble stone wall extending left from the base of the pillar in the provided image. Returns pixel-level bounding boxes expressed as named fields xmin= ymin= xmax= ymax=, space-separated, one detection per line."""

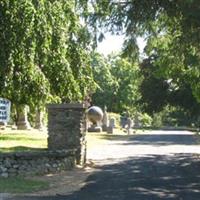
xmin=0 ymin=150 xmax=76 ymax=178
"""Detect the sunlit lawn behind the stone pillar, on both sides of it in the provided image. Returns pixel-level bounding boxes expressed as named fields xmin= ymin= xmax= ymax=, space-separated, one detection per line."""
xmin=0 ymin=129 xmax=133 ymax=153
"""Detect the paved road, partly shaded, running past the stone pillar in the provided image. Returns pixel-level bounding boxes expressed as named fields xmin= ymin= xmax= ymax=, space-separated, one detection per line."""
xmin=9 ymin=131 xmax=200 ymax=200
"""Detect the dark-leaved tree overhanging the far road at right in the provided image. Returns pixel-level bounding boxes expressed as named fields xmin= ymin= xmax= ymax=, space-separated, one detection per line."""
xmin=140 ymin=54 xmax=200 ymax=118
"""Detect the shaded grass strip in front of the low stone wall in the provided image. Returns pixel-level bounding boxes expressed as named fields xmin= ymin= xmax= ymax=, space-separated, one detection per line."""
xmin=0 ymin=177 xmax=49 ymax=193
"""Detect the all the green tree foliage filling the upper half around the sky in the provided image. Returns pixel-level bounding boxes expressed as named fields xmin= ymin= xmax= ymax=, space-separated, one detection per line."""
xmin=0 ymin=0 xmax=200 ymax=126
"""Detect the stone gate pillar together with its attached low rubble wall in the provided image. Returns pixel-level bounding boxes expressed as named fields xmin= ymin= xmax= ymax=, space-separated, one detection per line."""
xmin=0 ymin=104 xmax=86 ymax=177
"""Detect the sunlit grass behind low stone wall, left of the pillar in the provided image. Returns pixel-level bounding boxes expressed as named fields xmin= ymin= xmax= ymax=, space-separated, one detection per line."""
xmin=0 ymin=130 xmax=47 ymax=153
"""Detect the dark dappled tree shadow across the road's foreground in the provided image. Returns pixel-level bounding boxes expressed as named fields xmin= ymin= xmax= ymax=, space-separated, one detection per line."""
xmin=14 ymin=154 xmax=200 ymax=200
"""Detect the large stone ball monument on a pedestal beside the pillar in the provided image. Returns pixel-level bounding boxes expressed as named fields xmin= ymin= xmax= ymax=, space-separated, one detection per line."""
xmin=87 ymin=106 xmax=103 ymax=132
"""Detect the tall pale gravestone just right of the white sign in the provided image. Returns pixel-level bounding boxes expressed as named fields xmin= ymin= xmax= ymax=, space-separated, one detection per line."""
xmin=16 ymin=105 xmax=31 ymax=130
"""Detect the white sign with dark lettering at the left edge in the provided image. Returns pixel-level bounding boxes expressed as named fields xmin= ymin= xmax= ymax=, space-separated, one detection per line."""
xmin=0 ymin=98 xmax=11 ymax=122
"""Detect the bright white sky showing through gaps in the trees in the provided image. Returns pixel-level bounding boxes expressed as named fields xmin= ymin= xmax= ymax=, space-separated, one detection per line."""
xmin=97 ymin=33 xmax=146 ymax=56
